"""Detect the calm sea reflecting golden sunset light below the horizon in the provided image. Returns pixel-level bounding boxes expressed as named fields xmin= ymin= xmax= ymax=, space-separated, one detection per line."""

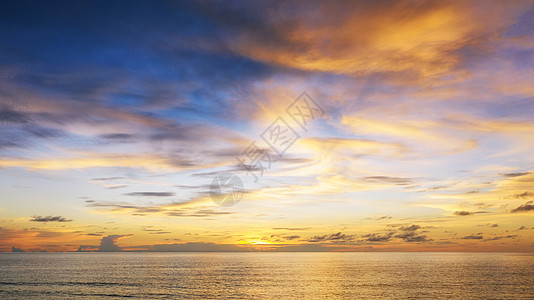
xmin=0 ymin=253 xmax=534 ymax=299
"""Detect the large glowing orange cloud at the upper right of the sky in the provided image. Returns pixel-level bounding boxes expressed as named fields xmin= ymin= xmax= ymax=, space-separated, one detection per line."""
xmin=217 ymin=1 xmax=520 ymax=78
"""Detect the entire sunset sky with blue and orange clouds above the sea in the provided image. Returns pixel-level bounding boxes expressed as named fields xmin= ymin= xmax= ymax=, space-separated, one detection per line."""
xmin=0 ymin=0 xmax=534 ymax=252
